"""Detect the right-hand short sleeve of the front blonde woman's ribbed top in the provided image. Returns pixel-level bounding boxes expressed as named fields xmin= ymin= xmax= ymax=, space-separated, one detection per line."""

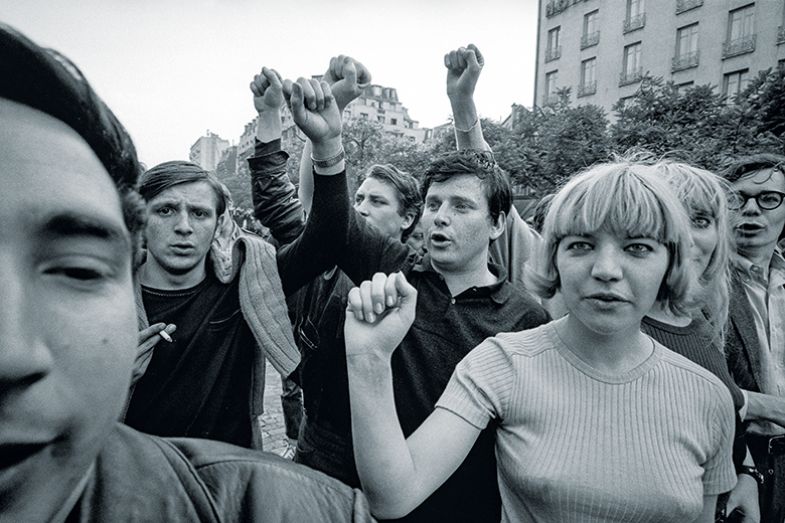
xmin=703 ymin=385 xmax=736 ymax=496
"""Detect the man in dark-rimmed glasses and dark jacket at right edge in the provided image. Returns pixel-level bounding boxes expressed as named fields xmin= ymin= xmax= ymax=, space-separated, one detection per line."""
xmin=722 ymin=154 xmax=785 ymax=521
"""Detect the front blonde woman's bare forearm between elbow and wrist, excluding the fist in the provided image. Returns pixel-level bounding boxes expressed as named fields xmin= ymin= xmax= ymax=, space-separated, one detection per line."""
xmin=346 ymin=353 xmax=417 ymax=519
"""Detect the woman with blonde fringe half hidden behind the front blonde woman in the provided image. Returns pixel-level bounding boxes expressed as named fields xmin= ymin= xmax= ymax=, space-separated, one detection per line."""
xmin=641 ymin=160 xmax=762 ymax=522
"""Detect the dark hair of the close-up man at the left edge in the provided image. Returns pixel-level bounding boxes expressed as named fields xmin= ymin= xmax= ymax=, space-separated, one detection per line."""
xmin=0 ymin=23 xmax=144 ymax=269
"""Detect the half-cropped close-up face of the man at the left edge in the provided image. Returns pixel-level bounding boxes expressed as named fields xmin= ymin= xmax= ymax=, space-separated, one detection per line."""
xmin=0 ymin=98 xmax=137 ymax=521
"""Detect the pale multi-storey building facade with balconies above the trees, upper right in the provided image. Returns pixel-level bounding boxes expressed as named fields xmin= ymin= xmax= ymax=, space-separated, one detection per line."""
xmin=534 ymin=0 xmax=785 ymax=114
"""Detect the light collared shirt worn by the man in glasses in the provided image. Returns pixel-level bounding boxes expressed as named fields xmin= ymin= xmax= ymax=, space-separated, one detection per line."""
xmin=734 ymin=249 xmax=785 ymax=432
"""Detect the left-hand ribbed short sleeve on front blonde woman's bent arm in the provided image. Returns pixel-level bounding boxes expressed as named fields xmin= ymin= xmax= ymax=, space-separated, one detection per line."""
xmin=436 ymin=337 xmax=515 ymax=430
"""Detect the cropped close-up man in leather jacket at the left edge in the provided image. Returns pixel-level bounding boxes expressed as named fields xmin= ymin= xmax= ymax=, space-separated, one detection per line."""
xmin=0 ymin=24 xmax=370 ymax=523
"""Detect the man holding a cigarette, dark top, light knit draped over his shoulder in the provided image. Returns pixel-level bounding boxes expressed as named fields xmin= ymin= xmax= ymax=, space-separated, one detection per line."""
xmin=125 ymin=63 xmax=362 ymax=448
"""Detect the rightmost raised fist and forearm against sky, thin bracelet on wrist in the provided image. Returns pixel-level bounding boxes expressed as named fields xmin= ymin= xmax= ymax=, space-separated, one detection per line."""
xmin=444 ymin=44 xmax=491 ymax=151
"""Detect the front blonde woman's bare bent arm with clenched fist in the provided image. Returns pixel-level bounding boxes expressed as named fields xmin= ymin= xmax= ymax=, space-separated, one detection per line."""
xmin=344 ymin=273 xmax=480 ymax=519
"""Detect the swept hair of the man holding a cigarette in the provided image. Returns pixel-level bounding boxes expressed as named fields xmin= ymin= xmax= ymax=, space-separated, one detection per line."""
xmin=139 ymin=160 xmax=227 ymax=216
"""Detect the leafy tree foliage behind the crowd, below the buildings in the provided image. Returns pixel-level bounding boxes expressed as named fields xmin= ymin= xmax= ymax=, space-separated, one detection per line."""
xmin=219 ymin=69 xmax=785 ymax=211
